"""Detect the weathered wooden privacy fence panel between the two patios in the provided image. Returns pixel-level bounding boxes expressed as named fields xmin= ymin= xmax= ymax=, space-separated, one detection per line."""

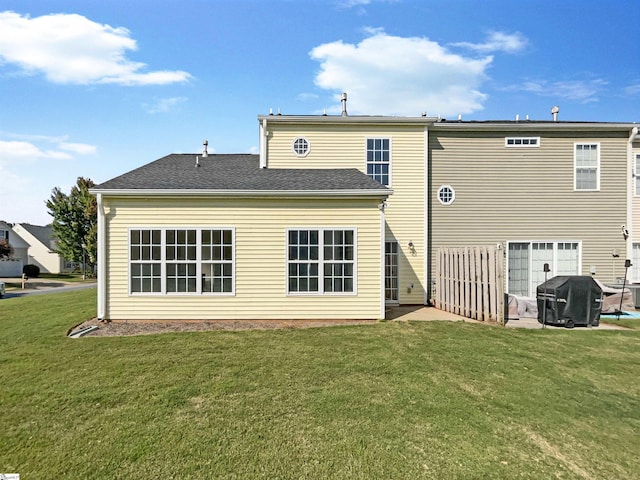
xmin=435 ymin=245 xmax=504 ymax=324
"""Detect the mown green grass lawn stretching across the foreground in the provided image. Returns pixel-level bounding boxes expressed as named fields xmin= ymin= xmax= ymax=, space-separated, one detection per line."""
xmin=0 ymin=291 xmax=640 ymax=480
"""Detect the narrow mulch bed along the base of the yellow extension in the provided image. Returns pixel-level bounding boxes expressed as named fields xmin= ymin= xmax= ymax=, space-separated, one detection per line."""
xmin=68 ymin=318 xmax=378 ymax=337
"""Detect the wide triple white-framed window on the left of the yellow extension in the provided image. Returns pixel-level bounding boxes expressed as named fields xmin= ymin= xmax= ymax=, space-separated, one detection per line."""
xmin=129 ymin=227 xmax=235 ymax=295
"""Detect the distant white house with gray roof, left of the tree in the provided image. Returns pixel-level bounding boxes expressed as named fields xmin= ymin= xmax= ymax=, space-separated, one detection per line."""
xmin=13 ymin=223 xmax=75 ymax=273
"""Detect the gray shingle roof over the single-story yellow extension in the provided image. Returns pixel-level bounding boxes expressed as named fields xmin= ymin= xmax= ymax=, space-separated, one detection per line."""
xmin=92 ymin=154 xmax=391 ymax=195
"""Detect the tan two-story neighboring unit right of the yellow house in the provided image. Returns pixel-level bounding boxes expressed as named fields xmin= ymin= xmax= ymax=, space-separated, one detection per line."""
xmin=429 ymin=121 xmax=637 ymax=297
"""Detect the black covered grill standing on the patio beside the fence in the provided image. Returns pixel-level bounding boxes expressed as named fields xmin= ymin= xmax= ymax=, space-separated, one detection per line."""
xmin=536 ymin=275 xmax=602 ymax=327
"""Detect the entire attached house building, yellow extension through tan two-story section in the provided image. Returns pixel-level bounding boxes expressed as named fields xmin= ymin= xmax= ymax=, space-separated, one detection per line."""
xmin=92 ymin=105 xmax=640 ymax=319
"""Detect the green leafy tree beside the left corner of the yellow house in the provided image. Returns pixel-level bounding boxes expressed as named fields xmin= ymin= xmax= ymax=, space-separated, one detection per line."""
xmin=47 ymin=177 xmax=98 ymax=271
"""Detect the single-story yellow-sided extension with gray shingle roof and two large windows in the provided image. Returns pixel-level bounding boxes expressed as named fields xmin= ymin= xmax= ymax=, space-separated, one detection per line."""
xmin=91 ymin=154 xmax=392 ymax=320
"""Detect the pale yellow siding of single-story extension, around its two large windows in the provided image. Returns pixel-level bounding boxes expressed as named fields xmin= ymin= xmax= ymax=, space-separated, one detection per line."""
xmin=104 ymin=198 xmax=382 ymax=320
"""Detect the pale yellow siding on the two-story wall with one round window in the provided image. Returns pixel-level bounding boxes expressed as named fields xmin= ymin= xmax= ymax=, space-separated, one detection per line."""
xmin=268 ymin=123 xmax=426 ymax=304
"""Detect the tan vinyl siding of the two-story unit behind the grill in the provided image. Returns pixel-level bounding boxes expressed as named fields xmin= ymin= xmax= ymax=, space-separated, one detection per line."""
xmin=430 ymin=130 xmax=628 ymax=282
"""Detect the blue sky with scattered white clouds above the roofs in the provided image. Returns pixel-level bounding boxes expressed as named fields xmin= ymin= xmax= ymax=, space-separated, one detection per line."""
xmin=0 ymin=0 xmax=640 ymax=224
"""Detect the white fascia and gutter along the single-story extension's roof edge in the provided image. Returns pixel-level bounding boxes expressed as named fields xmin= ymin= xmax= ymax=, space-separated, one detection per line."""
xmin=89 ymin=188 xmax=393 ymax=198
